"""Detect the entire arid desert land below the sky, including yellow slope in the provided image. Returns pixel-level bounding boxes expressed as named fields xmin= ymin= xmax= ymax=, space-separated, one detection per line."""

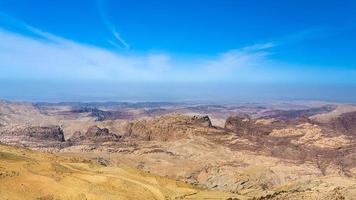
xmin=0 ymin=101 xmax=356 ymax=200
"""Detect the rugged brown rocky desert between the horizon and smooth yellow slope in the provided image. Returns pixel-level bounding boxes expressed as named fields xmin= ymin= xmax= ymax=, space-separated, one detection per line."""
xmin=0 ymin=103 xmax=356 ymax=199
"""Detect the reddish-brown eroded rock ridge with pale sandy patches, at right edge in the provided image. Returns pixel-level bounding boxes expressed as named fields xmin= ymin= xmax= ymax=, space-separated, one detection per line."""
xmin=225 ymin=113 xmax=356 ymax=178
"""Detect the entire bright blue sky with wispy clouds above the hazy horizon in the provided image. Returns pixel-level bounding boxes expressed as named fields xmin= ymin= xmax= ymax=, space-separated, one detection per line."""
xmin=0 ymin=0 xmax=356 ymax=102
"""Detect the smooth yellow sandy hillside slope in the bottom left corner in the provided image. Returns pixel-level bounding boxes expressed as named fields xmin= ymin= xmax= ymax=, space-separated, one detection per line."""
xmin=0 ymin=144 xmax=241 ymax=200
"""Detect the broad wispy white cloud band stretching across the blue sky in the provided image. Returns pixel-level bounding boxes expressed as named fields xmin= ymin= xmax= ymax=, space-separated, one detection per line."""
xmin=0 ymin=13 xmax=355 ymax=83
